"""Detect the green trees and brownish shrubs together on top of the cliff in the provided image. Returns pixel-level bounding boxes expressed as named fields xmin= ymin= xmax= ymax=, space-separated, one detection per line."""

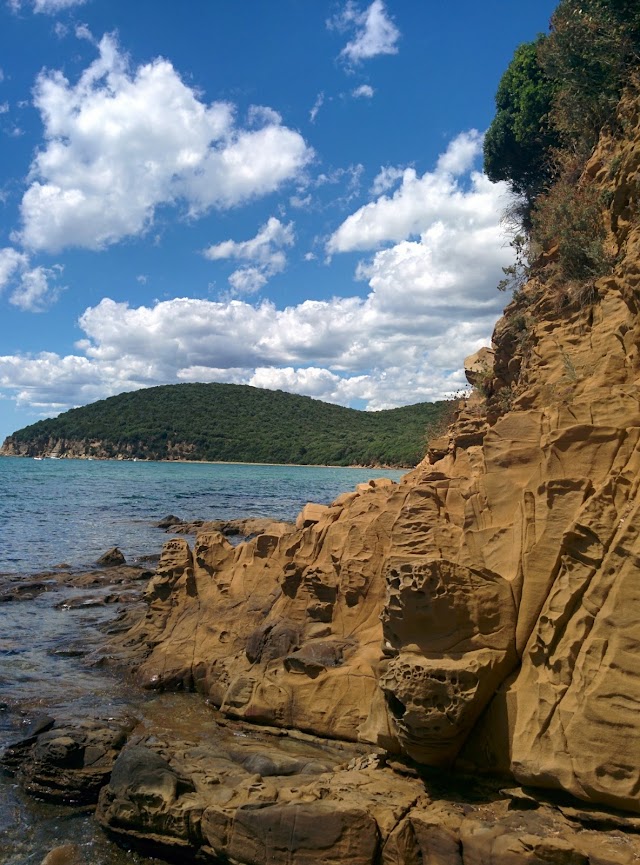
xmin=484 ymin=0 xmax=640 ymax=290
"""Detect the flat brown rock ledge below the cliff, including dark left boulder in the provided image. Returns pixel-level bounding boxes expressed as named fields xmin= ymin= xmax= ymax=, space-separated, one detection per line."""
xmin=1 ymin=716 xmax=640 ymax=865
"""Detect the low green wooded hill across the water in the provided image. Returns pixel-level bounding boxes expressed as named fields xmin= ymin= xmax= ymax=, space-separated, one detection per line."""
xmin=3 ymin=384 xmax=451 ymax=466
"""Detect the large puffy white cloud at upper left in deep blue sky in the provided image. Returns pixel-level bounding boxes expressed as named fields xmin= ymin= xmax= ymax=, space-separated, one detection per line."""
xmin=19 ymin=36 xmax=312 ymax=250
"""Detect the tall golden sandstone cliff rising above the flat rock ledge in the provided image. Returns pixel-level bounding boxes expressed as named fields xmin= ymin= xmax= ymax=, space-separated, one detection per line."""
xmin=111 ymin=89 xmax=640 ymax=824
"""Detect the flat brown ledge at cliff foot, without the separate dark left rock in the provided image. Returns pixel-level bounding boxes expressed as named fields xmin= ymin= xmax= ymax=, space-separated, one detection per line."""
xmin=97 ymin=732 xmax=640 ymax=865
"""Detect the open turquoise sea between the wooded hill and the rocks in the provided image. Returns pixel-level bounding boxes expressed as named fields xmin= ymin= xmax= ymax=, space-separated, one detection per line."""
xmin=0 ymin=457 xmax=403 ymax=573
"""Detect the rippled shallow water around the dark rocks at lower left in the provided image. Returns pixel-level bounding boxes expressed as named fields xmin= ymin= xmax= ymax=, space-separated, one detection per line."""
xmin=0 ymin=572 xmax=182 ymax=865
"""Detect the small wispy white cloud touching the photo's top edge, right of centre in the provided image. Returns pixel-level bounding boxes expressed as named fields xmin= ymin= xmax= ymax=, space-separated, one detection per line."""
xmin=328 ymin=0 xmax=400 ymax=63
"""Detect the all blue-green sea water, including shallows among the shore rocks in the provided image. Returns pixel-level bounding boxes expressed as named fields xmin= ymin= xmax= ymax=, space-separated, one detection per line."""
xmin=0 ymin=458 xmax=403 ymax=865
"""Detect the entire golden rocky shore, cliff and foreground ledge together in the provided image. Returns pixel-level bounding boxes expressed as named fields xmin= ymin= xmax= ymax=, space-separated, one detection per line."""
xmin=6 ymin=32 xmax=640 ymax=865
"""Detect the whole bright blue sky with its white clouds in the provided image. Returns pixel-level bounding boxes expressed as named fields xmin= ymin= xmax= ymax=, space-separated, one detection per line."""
xmin=0 ymin=0 xmax=555 ymax=439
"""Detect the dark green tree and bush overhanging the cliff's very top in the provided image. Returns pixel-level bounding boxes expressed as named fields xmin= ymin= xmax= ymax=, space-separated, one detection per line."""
xmin=484 ymin=0 xmax=640 ymax=208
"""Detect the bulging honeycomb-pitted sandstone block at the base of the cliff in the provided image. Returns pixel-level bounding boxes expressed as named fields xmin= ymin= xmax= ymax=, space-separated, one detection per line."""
xmin=380 ymin=556 xmax=515 ymax=765
